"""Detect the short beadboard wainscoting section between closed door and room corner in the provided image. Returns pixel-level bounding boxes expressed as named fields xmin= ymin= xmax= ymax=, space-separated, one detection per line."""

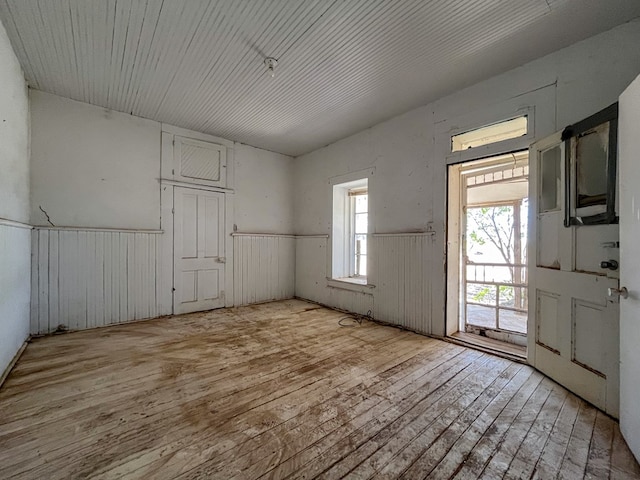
xmin=232 ymin=233 xmax=296 ymax=306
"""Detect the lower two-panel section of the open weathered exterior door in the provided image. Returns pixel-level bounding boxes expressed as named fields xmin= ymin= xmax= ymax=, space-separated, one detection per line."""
xmin=535 ymin=269 xmax=618 ymax=416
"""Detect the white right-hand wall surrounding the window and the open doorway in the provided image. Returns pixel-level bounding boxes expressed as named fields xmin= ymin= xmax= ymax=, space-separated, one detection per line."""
xmin=294 ymin=17 xmax=640 ymax=335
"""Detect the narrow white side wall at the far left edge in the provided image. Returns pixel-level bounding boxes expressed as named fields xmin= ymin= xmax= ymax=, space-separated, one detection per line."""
xmin=0 ymin=18 xmax=31 ymax=373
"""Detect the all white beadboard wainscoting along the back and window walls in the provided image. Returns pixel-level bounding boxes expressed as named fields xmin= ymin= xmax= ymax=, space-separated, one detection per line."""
xmin=30 ymin=227 xmax=433 ymax=334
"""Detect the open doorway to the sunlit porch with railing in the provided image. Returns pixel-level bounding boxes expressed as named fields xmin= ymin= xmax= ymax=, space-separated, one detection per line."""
xmin=447 ymin=150 xmax=529 ymax=357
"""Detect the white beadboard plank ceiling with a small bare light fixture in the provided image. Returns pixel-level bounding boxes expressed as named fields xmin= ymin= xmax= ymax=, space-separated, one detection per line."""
xmin=0 ymin=0 xmax=640 ymax=155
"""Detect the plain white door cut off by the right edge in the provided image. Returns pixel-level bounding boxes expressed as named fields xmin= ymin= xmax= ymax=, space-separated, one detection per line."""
xmin=618 ymin=77 xmax=640 ymax=459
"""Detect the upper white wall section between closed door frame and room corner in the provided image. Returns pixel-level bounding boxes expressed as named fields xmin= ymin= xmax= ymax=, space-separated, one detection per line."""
xmin=234 ymin=143 xmax=293 ymax=234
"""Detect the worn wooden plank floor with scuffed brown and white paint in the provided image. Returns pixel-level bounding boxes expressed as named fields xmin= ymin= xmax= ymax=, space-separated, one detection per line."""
xmin=0 ymin=300 xmax=640 ymax=479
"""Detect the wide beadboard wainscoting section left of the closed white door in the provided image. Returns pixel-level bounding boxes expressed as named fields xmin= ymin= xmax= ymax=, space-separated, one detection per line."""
xmin=31 ymin=227 xmax=166 ymax=334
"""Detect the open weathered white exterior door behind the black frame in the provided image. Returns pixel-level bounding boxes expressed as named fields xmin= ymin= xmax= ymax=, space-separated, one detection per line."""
xmin=527 ymin=133 xmax=619 ymax=417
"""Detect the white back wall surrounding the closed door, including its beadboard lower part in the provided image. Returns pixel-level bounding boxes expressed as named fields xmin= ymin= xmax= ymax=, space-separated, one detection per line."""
xmin=30 ymin=90 xmax=295 ymax=324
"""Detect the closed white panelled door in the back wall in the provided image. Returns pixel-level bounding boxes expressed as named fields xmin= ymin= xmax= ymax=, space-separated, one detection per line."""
xmin=174 ymin=187 xmax=226 ymax=313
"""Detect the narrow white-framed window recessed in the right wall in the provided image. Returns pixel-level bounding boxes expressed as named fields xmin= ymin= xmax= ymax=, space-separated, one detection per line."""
xmin=331 ymin=178 xmax=369 ymax=284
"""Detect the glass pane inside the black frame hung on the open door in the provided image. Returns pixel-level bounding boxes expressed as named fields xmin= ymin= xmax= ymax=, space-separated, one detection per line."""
xmin=576 ymin=123 xmax=609 ymax=207
